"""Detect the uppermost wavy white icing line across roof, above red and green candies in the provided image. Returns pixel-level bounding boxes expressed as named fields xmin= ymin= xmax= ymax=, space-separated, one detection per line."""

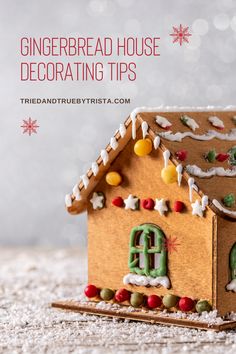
xmin=158 ymin=128 xmax=236 ymax=141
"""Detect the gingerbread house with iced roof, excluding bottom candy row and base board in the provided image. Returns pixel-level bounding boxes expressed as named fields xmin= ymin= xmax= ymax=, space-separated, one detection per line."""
xmin=54 ymin=107 xmax=236 ymax=330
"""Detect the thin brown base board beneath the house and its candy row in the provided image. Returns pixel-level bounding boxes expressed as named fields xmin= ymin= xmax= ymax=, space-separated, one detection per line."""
xmin=51 ymin=300 xmax=236 ymax=332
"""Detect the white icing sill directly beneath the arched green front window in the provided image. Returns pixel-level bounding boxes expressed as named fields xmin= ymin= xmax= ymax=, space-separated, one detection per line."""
xmin=123 ymin=273 xmax=170 ymax=289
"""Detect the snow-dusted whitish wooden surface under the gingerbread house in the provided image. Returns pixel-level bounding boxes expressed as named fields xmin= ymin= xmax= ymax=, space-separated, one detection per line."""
xmin=0 ymin=249 xmax=236 ymax=354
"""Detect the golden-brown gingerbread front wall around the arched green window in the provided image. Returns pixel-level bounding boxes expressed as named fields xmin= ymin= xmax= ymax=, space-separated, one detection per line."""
xmin=88 ymin=129 xmax=214 ymax=301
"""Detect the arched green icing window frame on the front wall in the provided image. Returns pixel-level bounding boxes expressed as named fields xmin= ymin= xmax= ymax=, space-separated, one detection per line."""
xmin=128 ymin=224 xmax=167 ymax=278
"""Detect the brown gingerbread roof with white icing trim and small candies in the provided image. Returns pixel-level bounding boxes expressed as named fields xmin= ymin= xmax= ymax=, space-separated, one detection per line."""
xmin=66 ymin=107 xmax=236 ymax=219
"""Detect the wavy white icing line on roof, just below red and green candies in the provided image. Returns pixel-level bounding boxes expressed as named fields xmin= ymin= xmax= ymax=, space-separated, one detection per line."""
xmin=185 ymin=165 xmax=236 ymax=178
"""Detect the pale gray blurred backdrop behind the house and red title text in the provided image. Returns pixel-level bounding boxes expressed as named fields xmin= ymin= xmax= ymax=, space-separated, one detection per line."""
xmin=0 ymin=0 xmax=236 ymax=245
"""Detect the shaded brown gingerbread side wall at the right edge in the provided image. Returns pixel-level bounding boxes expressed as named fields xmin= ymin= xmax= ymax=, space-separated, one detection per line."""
xmin=214 ymin=217 xmax=236 ymax=315
